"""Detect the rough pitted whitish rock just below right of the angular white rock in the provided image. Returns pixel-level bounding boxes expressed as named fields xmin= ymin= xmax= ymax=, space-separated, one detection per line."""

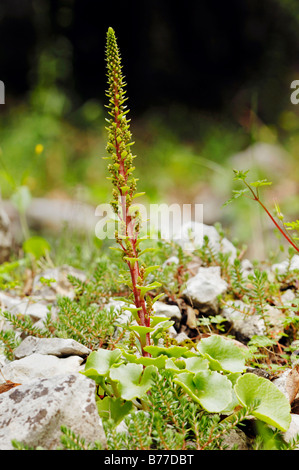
xmin=221 ymin=300 xmax=266 ymax=339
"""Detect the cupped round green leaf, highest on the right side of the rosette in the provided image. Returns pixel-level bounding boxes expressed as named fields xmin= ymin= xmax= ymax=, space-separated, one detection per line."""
xmin=197 ymin=335 xmax=245 ymax=372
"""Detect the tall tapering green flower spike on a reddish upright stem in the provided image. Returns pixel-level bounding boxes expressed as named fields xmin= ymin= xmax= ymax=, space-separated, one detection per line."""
xmin=106 ymin=28 xmax=157 ymax=356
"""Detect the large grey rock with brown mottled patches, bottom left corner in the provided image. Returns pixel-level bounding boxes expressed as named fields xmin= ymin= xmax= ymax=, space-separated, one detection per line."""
xmin=0 ymin=374 xmax=106 ymax=450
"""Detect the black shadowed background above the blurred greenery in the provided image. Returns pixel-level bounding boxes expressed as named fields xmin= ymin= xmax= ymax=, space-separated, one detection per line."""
xmin=0 ymin=0 xmax=299 ymax=122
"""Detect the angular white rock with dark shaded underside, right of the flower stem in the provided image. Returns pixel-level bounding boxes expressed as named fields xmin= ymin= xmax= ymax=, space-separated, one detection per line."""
xmin=183 ymin=266 xmax=228 ymax=313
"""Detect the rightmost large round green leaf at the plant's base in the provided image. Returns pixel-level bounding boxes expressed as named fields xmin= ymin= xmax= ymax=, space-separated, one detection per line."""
xmin=234 ymin=374 xmax=291 ymax=431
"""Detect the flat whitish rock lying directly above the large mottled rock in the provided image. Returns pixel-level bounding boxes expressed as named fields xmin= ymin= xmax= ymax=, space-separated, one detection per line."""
xmin=2 ymin=353 xmax=84 ymax=384
